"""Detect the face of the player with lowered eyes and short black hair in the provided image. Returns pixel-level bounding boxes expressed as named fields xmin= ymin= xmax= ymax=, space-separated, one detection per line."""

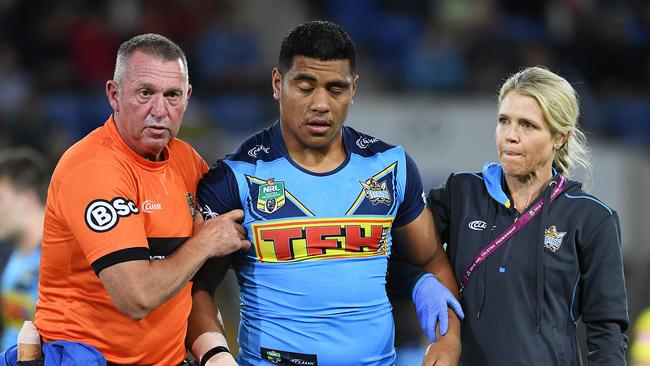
xmin=273 ymin=56 xmax=358 ymax=149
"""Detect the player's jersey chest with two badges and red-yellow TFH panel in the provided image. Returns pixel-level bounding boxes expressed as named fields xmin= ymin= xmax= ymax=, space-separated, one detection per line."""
xmin=240 ymin=162 xmax=403 ymax=262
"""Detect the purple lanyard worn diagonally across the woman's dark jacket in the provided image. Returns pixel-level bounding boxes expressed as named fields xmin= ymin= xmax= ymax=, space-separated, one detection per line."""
xmin=460 ymin=175 xmax=566 ymax=293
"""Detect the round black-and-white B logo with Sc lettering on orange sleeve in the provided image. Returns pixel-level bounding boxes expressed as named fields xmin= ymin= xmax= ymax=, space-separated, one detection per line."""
xmin=85 ymin=197 xmax=139 ymax=233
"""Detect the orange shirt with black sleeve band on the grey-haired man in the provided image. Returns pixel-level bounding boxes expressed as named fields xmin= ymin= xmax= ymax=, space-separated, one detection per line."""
xmin=35 ymin=117 xmax=207 ymax=365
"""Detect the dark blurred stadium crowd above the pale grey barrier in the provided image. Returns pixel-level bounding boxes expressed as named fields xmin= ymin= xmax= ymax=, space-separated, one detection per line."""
xmin=0 ymin=0 xmax=650 ymax=364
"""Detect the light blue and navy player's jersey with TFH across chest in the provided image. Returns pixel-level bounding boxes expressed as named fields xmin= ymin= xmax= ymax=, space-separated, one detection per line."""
xmin=197 ymin=122 xmax=424 ymax=366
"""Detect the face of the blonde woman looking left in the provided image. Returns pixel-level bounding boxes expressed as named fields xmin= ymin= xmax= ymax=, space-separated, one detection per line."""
xmin=496 ymin=92 xmax=555 ymax=177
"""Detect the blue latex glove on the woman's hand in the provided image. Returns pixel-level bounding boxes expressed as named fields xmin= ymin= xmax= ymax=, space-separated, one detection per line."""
xmin=413 ymin=273 xmax=465 ymax=342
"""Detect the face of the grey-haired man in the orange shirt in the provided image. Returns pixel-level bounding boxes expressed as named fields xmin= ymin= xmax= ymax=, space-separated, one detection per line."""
xmin=106 ymin=51 xmax=192 ymax=161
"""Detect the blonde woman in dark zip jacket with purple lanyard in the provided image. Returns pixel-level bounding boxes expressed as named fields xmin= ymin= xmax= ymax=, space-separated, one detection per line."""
xmin=391 ymin=67 xmax=628 ymax=366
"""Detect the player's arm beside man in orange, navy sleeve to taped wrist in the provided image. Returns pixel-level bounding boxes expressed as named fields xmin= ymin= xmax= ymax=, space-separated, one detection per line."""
xmin=185 ymin=161 xmax=241 ymax=366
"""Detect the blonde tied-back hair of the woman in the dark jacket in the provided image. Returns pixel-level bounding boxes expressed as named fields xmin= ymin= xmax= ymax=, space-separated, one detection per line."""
xmin=499 ymin=66 xmax=592 ymax=181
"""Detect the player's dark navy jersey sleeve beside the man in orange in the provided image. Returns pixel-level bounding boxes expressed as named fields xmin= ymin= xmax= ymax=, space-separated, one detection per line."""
xmin=196 ymin=160 xmax=242 ymax=220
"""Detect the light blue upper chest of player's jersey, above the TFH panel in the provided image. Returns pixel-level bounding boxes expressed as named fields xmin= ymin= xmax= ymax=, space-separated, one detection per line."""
xmin=240 ymin=161 xmax=404 ymax=219
